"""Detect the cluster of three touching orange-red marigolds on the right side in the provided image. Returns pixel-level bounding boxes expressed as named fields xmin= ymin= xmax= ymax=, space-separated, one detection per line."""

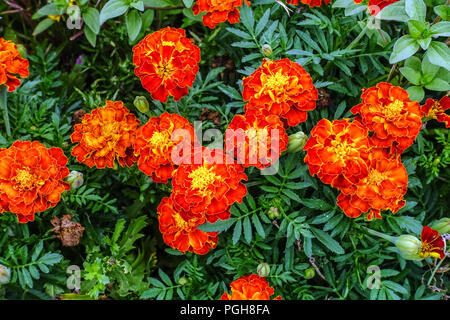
xmin=304 ymin=82 xmax=422 ymax=220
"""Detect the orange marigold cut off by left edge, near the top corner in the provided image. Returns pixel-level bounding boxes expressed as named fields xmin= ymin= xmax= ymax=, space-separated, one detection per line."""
xmin=0 ymin=38 xmax=29 ymax=92
